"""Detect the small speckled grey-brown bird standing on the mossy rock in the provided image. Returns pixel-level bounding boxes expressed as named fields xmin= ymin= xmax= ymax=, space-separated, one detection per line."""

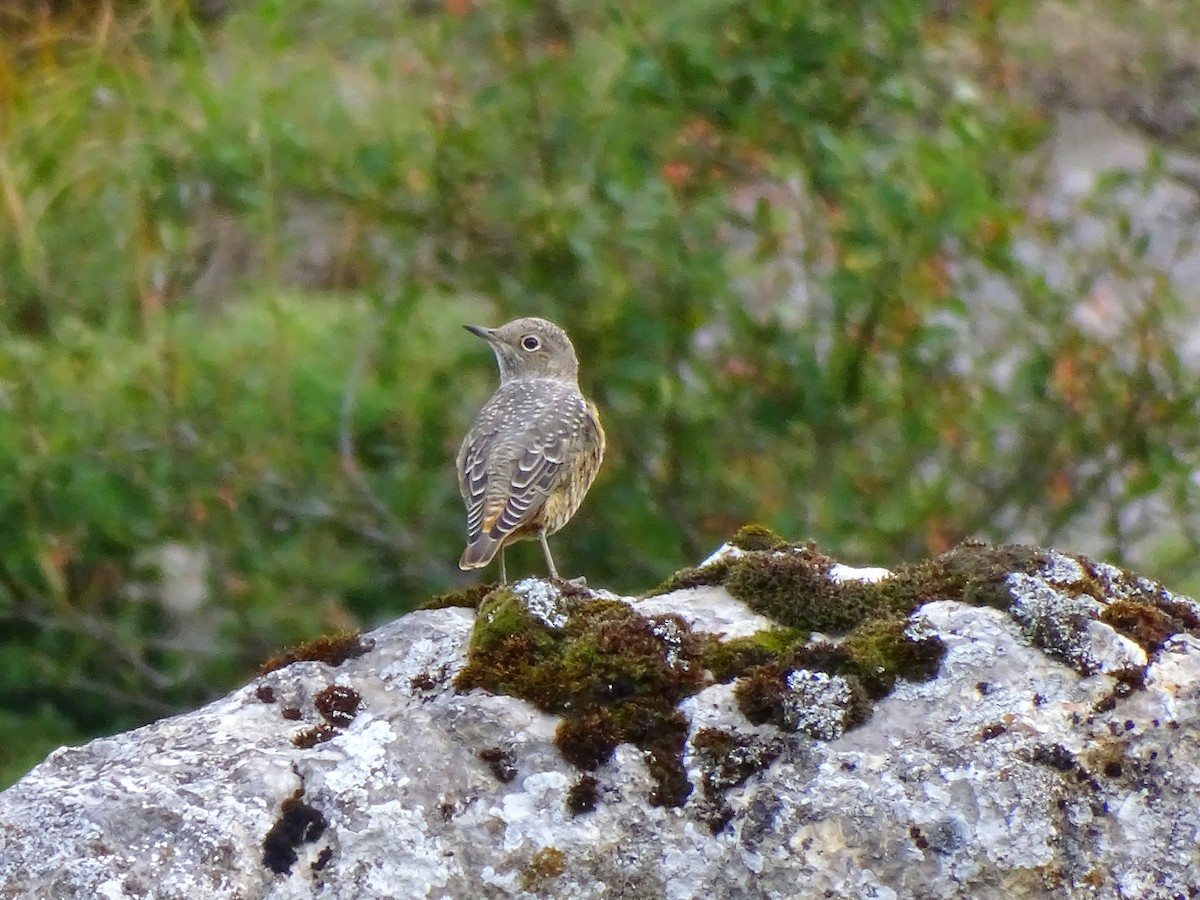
xmin=456 ymin=317 xmax=605 ymax=584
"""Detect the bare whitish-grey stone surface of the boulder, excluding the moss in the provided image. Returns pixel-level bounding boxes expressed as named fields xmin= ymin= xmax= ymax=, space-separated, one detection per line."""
xmin=0 ymin=575 xmax=1200 ymax=900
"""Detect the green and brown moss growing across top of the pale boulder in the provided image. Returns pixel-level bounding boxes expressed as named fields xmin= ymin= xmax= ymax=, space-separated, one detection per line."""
xmin=456 ymin=527 xmax=1200 ymax=829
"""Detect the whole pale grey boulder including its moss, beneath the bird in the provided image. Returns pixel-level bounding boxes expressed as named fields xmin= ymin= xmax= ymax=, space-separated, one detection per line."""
xmin=0 ymin=545 xmax=1200 ymax=900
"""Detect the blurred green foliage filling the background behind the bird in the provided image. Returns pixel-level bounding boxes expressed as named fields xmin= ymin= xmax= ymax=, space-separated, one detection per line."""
xmin=0 ymin=0 xmax=1200 ymax=784
